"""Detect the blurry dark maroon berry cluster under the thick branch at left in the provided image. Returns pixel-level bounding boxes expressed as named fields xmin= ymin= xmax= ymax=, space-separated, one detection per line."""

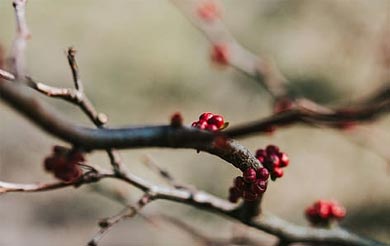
xmin=44 ymin=146 xmax=85 ymax=182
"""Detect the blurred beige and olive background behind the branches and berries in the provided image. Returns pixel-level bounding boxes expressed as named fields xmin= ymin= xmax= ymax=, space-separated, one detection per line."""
xmin=0 ymin=0 xmax=390 ymax=246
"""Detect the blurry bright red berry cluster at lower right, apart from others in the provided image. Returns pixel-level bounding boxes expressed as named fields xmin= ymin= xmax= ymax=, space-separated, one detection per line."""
xmin=305 ymin=200 xmax=346 ymax=226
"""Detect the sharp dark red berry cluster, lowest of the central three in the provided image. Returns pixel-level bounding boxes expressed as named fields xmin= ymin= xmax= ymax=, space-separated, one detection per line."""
xmin=229 ymin=167 xmax=269 ymax=202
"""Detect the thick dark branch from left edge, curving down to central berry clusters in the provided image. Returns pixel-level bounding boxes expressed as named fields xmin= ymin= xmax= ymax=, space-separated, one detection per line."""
xmin=0 ymin=78 xmax=261 ymax=170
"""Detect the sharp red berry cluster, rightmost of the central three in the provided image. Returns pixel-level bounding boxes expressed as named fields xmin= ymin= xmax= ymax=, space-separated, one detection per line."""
xmin=256 ymin=145 xmax=289 ymax=180
